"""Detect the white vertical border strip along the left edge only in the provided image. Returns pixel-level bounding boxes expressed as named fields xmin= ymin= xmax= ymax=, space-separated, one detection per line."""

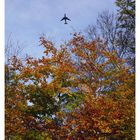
xmin=0 ymin=0 xmax=5 ymax=140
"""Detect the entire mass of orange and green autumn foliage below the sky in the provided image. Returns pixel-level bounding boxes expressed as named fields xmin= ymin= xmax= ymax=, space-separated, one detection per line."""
xmin=5 ymin=33 xmax=135 ymax=140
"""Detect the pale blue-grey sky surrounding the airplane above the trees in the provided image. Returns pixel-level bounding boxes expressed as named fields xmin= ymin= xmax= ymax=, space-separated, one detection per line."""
xmin=5 ymin=0 xmax=116 ymax=56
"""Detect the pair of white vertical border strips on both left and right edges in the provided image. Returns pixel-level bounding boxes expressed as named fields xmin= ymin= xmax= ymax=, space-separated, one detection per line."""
xmin=0 ymin=0 xmax=140 ymax=140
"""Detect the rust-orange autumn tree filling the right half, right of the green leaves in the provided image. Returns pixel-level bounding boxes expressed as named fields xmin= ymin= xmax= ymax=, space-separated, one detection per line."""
xmin=55 ymin=35 xmax=135 ymax=140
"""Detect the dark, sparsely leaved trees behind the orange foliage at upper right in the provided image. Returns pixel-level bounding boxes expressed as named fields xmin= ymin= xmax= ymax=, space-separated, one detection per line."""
xmin=86 ymin=4 xmax=135 ymax=69
